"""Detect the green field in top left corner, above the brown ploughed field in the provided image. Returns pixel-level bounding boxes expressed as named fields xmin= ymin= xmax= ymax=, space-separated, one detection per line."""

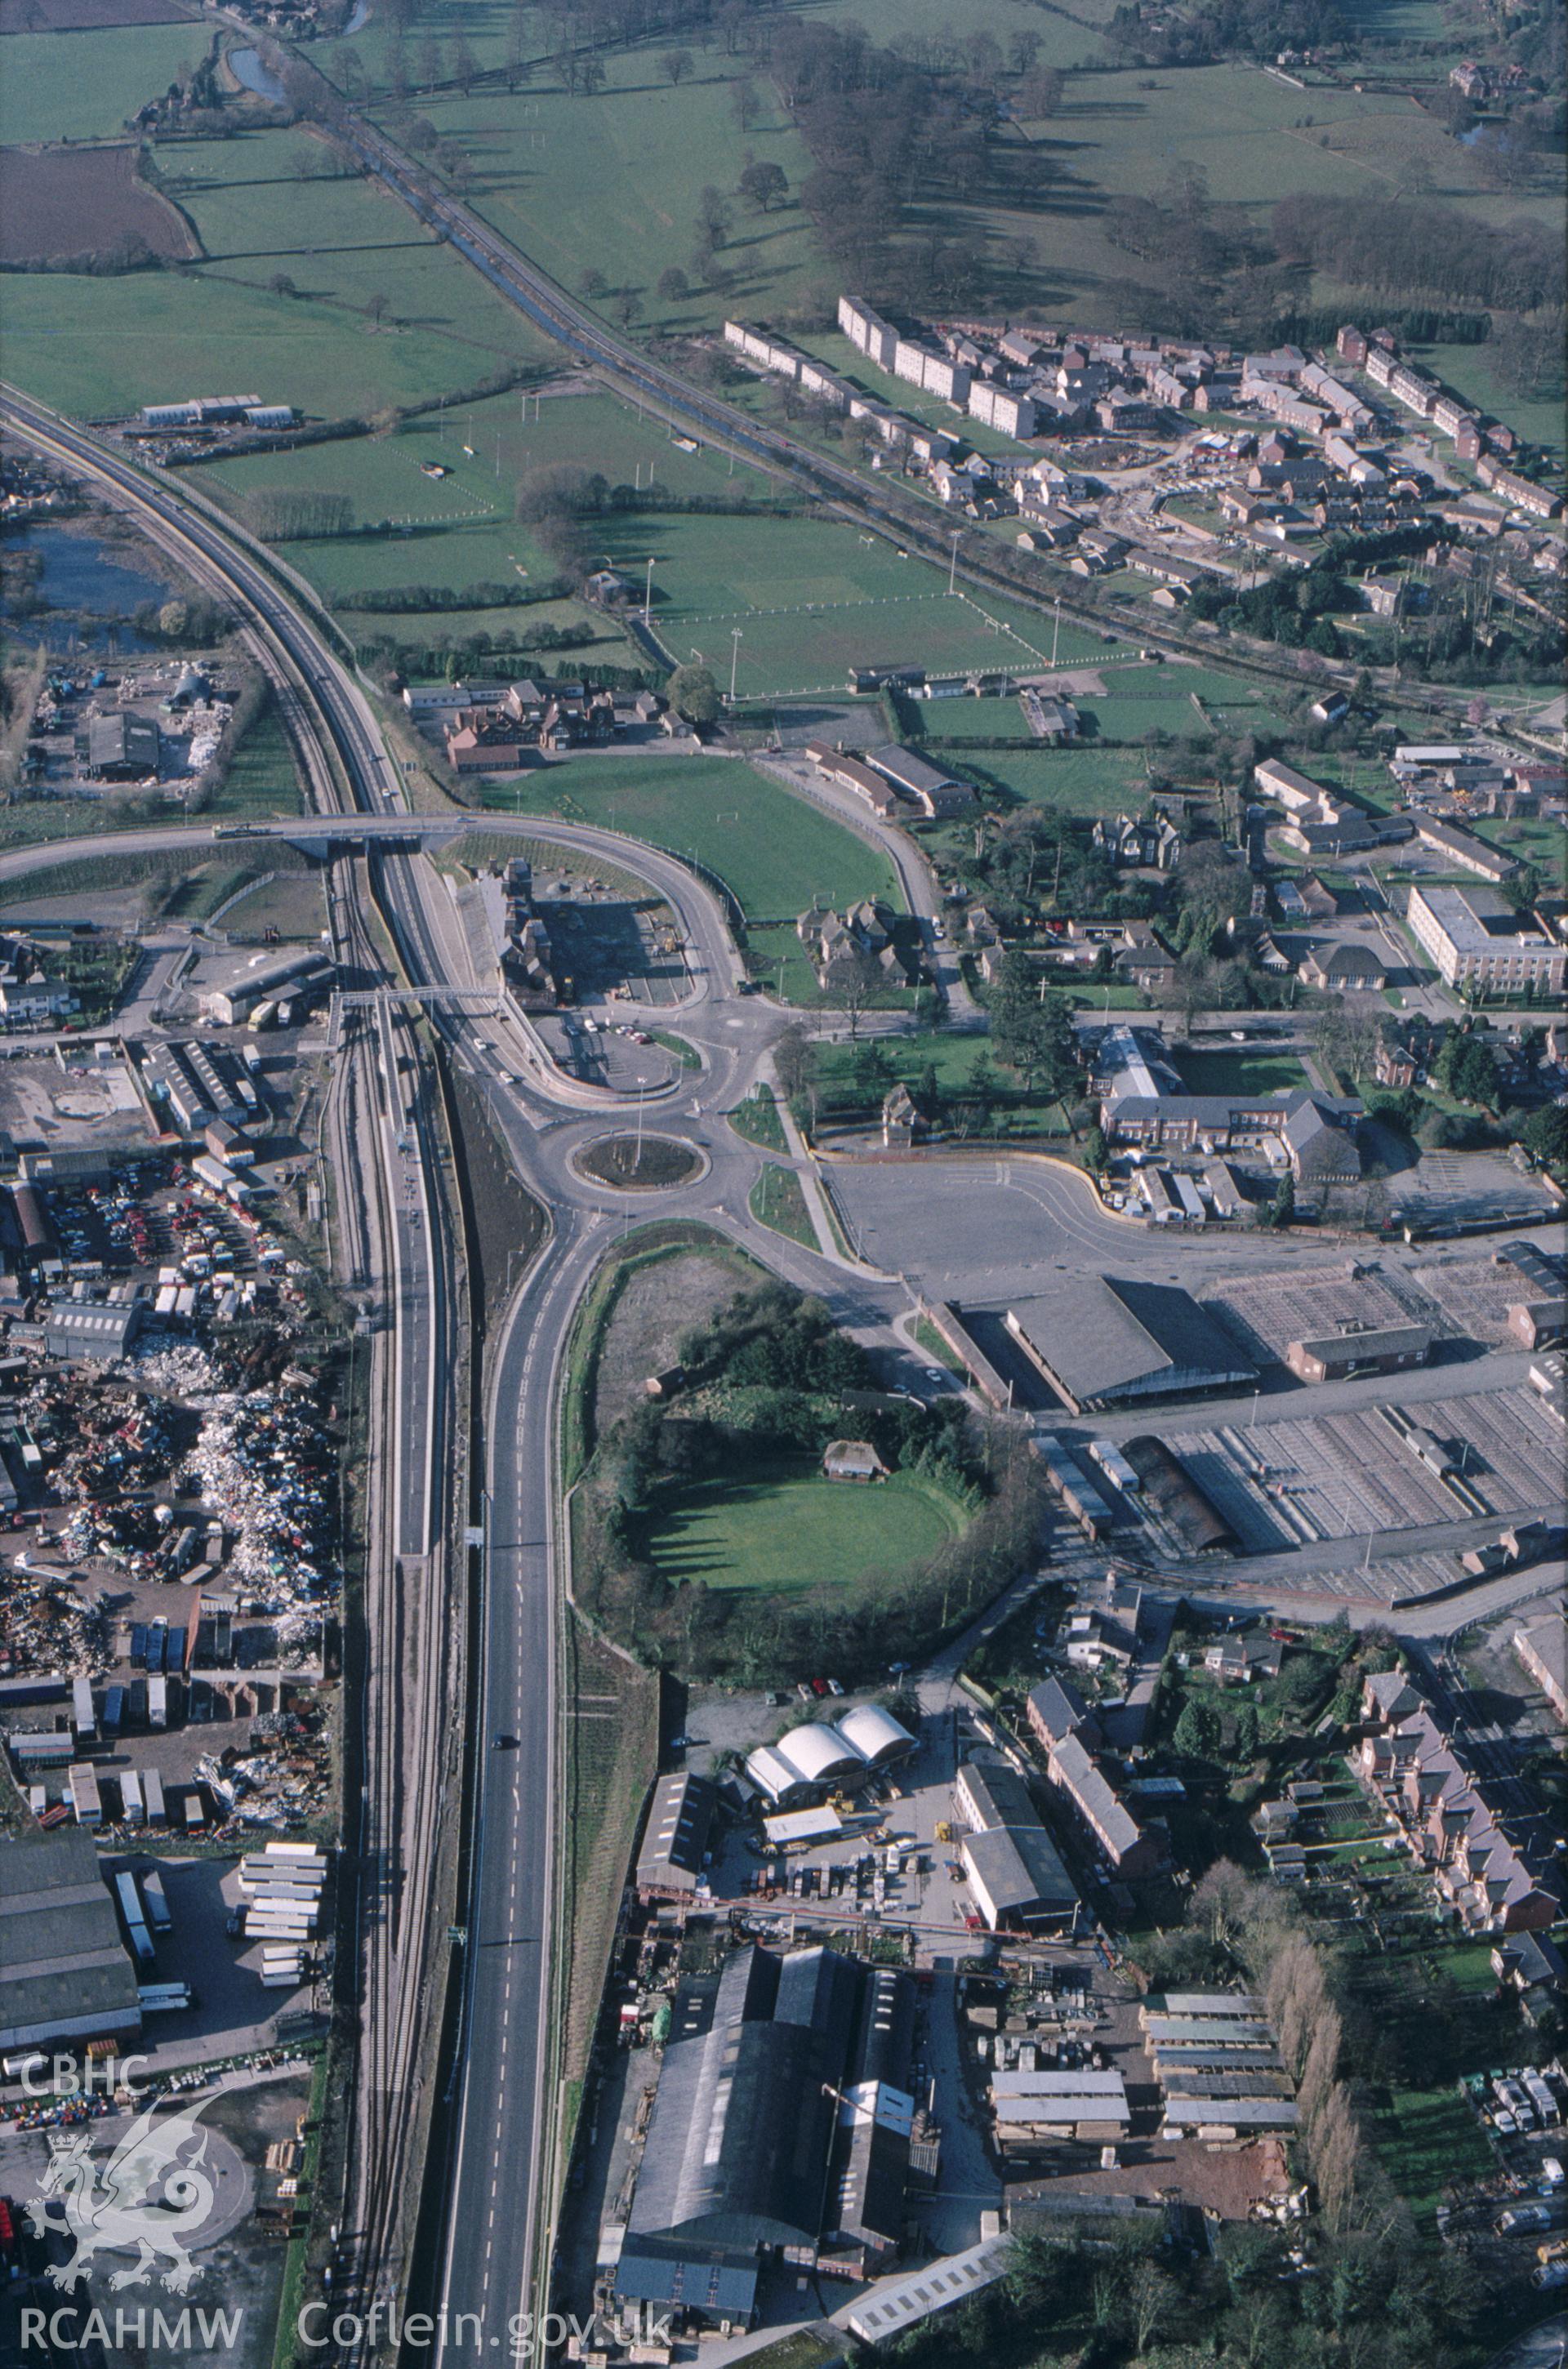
xmin=0 ymin=21 xmax=213 ymax=147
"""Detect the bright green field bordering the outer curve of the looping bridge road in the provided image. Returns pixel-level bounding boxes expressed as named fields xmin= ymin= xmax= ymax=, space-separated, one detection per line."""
xmin=486 ymin=755 xmax=902 ymax=917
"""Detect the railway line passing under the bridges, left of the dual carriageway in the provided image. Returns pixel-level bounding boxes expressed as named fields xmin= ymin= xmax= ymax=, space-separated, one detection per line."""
xmin=0 ymin=389 xmax=457 ymax=2369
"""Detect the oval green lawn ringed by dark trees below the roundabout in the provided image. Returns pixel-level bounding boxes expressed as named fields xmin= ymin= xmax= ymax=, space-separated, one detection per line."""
xmin=649 ymin=1457 xmax=964 ymax=1594
